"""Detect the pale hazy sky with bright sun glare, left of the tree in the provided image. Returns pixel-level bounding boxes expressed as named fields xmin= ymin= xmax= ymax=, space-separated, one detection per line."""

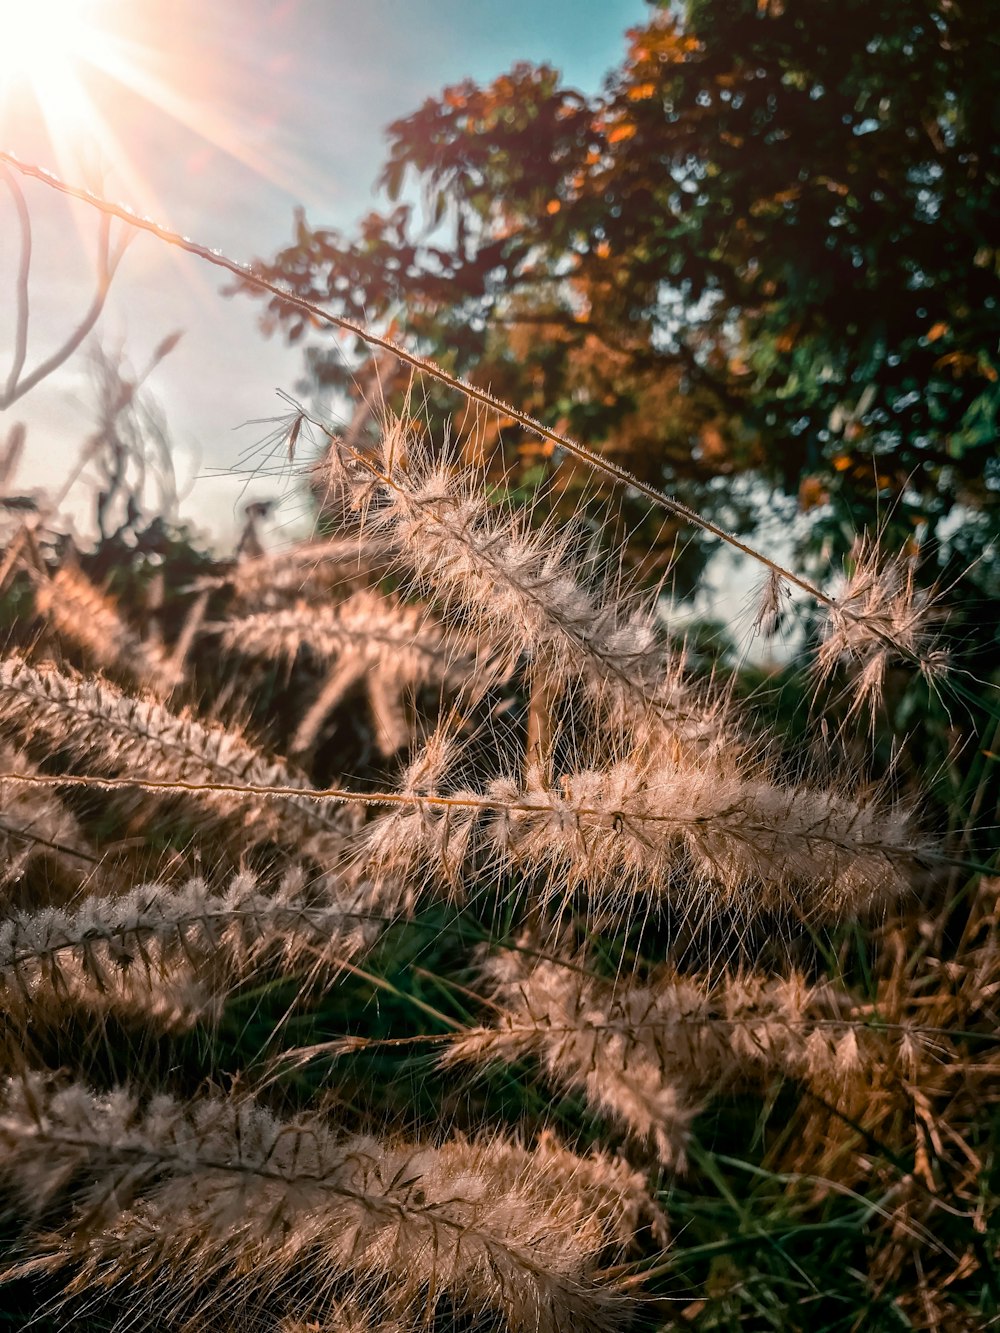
xmin=0 ymin=0 xmax=648 ymax=533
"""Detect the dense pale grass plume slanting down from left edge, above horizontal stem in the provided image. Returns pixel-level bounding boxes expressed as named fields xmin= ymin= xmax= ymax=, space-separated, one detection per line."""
xmin=0 ymin=656 xmax=357 ymax=866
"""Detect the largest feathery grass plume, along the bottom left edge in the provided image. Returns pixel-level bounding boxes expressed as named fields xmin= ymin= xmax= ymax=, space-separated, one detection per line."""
xmin=0 ymin=1073 xmax=629 ymax=1333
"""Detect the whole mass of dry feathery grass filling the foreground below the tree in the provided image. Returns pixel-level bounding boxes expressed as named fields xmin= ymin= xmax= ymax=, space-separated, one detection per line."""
xmin=0 ymin=163 xmax=1000 ymax=1333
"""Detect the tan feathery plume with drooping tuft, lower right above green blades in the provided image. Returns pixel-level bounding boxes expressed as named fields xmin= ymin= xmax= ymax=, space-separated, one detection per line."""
xmin=441 ymin=950 xmax=873 ymax=1170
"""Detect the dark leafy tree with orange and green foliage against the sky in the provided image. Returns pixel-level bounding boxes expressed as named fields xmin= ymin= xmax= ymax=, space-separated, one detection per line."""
xmin=237 ymin=0 xmax=1000 ymax=589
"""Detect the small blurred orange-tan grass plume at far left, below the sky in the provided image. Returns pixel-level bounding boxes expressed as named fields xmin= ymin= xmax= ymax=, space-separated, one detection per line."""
xmin=35 ymin=563 xmax=177 ymax=694
